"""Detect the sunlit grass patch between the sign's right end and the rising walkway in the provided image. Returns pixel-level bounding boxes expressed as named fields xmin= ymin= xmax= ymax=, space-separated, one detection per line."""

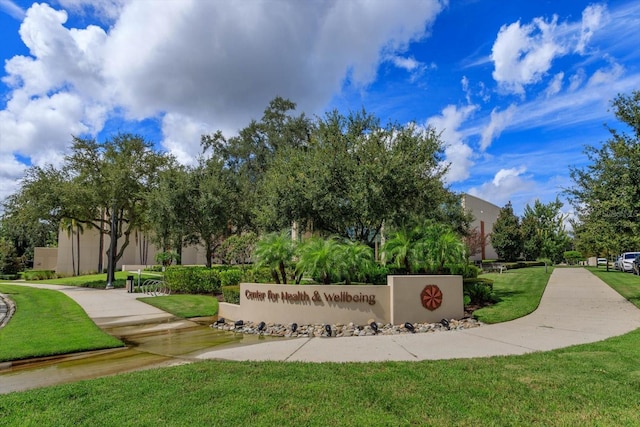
xmin=473 ymin=267 xmax=553 ymax=323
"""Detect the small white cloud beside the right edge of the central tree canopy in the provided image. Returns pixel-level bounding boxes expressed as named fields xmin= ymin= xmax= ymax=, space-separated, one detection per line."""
xmin=427 ymin=105 xmax=477 ymax=183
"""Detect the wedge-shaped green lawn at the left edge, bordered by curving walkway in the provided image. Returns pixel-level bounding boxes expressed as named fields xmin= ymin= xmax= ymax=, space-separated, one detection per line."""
xmin=0 ymin=284 xmax=123 ymax=361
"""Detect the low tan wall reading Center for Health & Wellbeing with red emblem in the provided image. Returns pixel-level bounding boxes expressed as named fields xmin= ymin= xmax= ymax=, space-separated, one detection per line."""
xmin=219 ymin=276 xmax=464 ymax=325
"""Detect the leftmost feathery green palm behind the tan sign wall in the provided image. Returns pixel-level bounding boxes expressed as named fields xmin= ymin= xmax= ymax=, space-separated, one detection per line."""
xmin=254 ymin=231 xmax=295 ymax=284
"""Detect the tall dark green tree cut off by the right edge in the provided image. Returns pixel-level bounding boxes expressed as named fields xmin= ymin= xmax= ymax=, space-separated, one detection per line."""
xmin=566 ymin=91 xmax=640 ymax=255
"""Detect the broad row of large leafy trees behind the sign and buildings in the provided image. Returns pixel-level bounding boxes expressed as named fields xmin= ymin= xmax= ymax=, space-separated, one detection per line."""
xmin=0 ymin=97 xmax=471 ymax=273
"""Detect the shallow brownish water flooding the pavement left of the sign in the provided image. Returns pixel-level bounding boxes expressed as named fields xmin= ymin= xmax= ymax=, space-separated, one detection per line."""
xmin=0 ymin=319 xmax=277 ymax=394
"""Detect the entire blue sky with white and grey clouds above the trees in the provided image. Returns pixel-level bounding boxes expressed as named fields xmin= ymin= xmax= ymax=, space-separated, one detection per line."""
xmin=0 ymin=0 xmax=640 ymax=214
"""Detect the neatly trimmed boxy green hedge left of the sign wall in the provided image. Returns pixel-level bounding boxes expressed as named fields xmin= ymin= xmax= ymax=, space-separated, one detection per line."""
xmin=164 ymin=266 xmax=220 ymax=294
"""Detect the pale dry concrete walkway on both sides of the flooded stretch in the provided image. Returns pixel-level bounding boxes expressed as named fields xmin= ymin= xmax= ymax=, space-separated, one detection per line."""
xmin=7 ymin=268 xmax=640 ymax=362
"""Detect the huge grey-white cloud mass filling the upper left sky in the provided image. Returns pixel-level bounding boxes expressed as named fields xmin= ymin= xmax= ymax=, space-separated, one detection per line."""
xmin=0 ymin=0 xmax=447 ymax=199
